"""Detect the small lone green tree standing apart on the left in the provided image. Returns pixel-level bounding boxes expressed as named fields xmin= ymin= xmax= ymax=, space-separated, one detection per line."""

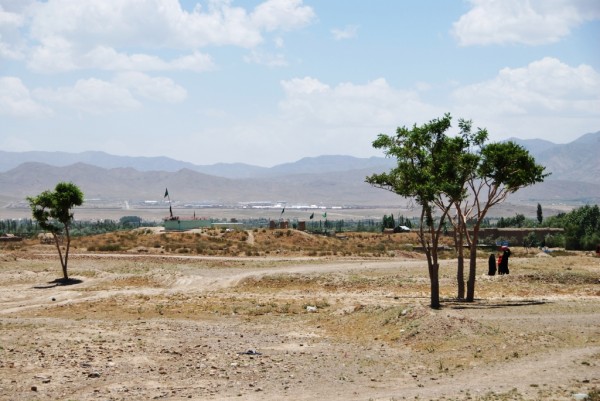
xmin=27 ymin=182 xmax=83 ymax=281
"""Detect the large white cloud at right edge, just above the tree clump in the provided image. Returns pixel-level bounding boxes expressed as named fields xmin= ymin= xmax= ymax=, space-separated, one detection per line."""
xmin=453 ymin=57 xmax=600 ymax=142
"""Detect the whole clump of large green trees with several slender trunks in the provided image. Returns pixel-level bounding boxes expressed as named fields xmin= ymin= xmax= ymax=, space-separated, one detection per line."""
xmin=366 ymin=113 xmax=547 ymax=307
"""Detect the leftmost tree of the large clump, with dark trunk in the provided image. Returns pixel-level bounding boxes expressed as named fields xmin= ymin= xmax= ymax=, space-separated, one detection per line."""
xmin=366 ymin=114 xmax=470 ymax=308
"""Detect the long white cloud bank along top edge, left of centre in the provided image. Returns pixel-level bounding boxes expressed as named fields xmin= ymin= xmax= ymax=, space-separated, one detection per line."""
xmin=24 ymin=0 xmax=315 ymax=57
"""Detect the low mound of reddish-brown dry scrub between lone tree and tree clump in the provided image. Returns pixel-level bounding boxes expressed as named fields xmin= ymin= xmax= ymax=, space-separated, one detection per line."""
xmin=68 ymin=229 xmax=450 ymax=256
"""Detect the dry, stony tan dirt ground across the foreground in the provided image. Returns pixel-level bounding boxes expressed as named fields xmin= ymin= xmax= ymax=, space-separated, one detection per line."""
xmin=0 ymin=236 xmax=600 ymax=401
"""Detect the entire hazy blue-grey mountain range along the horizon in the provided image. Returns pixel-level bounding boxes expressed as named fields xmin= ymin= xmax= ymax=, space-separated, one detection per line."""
xmin=0 ymin=131 xmax=600 ymax=206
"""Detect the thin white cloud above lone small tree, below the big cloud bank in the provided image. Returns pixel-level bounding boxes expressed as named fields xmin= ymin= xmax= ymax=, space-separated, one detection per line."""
xmin=34 ymin=78 xmax=141 ymax=115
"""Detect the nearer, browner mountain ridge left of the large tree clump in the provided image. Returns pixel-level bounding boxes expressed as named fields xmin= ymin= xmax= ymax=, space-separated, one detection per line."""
xmin=0 ymin=163 xmax=398 ymax=205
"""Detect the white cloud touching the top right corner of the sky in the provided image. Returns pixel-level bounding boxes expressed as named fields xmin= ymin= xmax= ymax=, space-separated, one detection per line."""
xmin=452 ymin=0 xmax=600 ymax=46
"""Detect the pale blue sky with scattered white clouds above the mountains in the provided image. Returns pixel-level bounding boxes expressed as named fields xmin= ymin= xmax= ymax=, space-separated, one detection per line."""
xmin=0 ymin=0 xmax=600 ymax=167
